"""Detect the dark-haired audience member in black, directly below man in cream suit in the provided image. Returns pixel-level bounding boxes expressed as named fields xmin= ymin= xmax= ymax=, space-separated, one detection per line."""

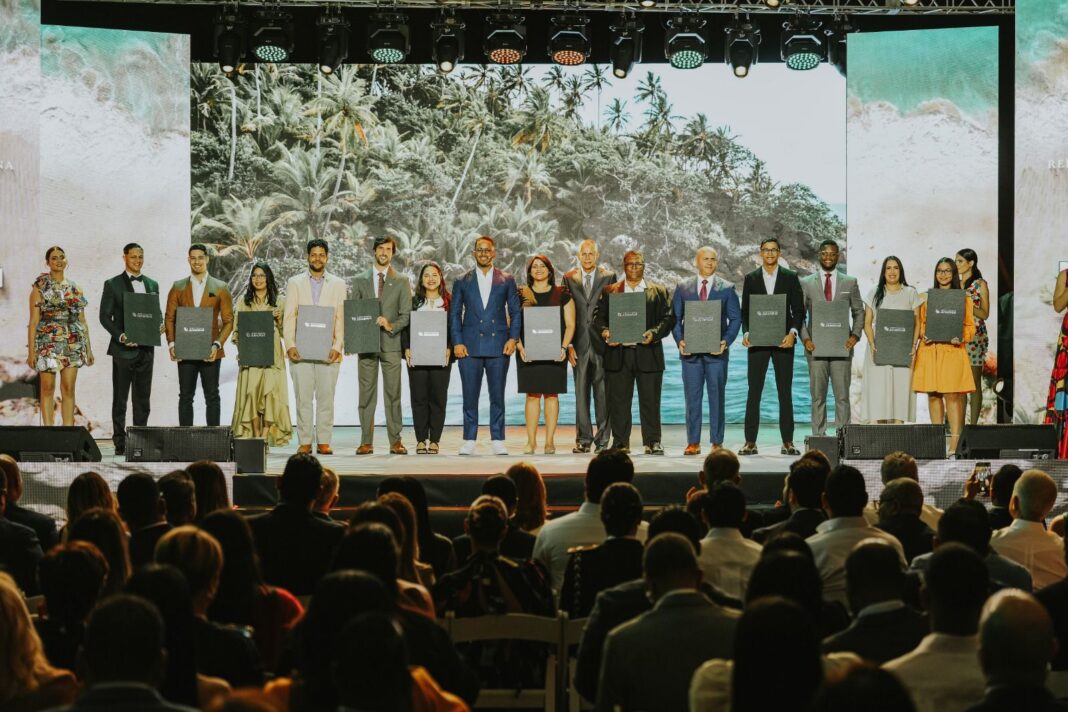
xmin=245 ymin=454 xmax=345 ymax=596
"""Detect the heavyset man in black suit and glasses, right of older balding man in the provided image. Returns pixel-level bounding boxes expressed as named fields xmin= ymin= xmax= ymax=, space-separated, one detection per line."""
xmin=593 ymin=250 xmax=675 ymax=455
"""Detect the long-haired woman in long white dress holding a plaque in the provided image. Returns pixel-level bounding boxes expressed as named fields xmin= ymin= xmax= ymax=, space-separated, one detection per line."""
xmin=860 ymin=255 xmax=923 ymax=423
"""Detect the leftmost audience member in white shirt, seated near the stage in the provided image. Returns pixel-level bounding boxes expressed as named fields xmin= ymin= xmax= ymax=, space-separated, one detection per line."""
xmin=534 ymin=449 xmax=647 ymax=595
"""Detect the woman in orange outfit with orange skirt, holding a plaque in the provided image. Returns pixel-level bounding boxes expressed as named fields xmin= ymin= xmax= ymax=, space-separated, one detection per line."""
xmin=912 ymin=257 xmax=975 ymax=453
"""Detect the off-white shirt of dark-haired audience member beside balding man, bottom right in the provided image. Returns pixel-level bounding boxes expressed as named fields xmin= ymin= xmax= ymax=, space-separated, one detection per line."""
xmin=883 ymin=633 xmax=987 ymax=712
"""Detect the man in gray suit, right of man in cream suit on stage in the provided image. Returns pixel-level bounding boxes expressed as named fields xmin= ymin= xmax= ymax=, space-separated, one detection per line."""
xmin=352 ymin=237 xmax=411 ymax=455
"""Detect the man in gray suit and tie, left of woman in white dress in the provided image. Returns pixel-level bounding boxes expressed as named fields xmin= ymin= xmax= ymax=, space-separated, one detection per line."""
xmin=801 ymin=240 xmax=864 ymax=436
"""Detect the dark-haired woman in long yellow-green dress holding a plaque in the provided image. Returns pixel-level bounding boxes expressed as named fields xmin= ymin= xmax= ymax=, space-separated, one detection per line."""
xmin=231 ymin=262 xmax=293 ymax=445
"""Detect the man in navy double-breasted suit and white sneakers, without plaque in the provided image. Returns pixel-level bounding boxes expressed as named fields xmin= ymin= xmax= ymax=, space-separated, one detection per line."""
xmin=449 ymin=235 xmax=522 ymax=455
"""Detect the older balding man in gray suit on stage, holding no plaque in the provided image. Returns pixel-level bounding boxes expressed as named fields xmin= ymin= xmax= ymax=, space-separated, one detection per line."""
xmin=564 ymin=239 xmax=616 ymax=453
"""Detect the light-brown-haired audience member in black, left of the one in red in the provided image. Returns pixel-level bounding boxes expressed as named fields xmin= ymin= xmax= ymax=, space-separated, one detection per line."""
xmin=156 ymin=525 xmax=263 ymax=687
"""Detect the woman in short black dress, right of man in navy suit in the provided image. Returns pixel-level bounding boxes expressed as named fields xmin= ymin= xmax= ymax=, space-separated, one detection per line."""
xmin=516 ymin=255 xmax=576 ymax=455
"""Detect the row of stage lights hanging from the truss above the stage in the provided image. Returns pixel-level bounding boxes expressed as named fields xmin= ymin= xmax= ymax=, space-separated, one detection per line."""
xmin=214 ymin=7 xmax=854 ymax=79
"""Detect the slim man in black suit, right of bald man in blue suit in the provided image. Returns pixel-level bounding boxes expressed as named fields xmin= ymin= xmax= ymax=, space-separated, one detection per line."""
xmin=738 ymin=237 xmax=804 ymax=455
